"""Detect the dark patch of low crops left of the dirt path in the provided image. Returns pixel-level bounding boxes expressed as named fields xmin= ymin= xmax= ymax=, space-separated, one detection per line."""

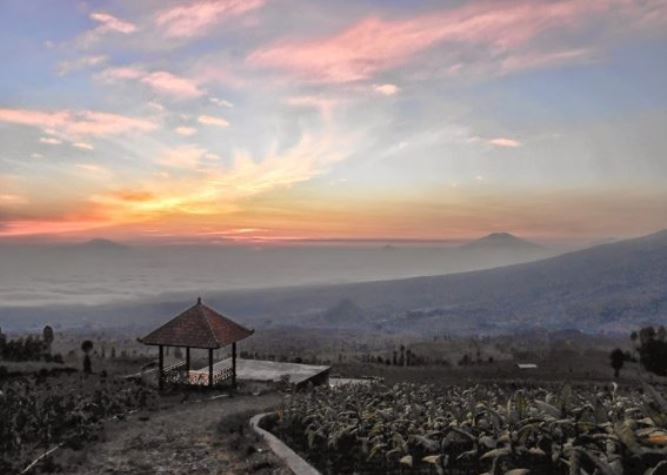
xmin=0 ymin=374 xmax=157 ymax=473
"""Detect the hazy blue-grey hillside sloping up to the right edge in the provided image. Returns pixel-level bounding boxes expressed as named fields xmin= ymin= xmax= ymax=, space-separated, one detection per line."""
xmin=204 ymin=231 xmax=667 ymax=333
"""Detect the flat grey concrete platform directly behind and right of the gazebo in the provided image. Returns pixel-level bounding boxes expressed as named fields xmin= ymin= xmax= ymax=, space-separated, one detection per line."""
xmin=191 ymin=358 xmax=331 ymax=386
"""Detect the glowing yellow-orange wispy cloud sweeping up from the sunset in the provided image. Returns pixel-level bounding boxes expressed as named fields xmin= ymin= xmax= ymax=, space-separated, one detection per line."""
xmin=85 ymin=130 xmax=349 ymax=229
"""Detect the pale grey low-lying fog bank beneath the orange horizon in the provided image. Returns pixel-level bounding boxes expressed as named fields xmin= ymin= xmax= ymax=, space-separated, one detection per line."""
xmin=0 ymin=241 xmax=556 ymax=307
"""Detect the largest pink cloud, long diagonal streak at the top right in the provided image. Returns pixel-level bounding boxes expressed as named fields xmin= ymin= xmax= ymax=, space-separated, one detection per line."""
xmin=247 ymin=0 xmax=664 ymax=82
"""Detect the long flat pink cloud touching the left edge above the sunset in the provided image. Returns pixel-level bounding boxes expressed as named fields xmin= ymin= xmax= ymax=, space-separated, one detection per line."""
xmin=0 ymin=109 xmax=157 ymax=136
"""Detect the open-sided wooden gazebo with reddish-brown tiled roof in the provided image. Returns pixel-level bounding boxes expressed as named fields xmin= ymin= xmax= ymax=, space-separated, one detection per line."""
xmin=139 ymin=297 xmax=254 ymax=389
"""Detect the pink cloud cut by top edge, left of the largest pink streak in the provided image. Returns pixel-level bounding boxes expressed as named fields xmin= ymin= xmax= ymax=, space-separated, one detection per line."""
xmin=155 ymin=0 xmax=266 ymax=38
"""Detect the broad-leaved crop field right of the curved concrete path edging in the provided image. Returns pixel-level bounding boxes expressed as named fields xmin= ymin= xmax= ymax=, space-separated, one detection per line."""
xmin=268 ymin=384 xmax=667 ymax=475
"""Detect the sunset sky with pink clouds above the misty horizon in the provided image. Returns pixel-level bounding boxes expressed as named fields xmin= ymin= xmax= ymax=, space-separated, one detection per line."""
xmin=0 ymin=0 xmax=667 ymax=243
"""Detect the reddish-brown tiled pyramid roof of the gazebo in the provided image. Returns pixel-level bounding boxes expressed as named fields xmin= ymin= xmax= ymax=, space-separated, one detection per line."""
xmin=139 ymin=298 xmax=254 ymax=348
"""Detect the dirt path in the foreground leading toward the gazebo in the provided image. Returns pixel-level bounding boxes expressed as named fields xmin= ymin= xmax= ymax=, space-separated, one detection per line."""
xmin=65 ymin=394 xmax=290 ymax=474
